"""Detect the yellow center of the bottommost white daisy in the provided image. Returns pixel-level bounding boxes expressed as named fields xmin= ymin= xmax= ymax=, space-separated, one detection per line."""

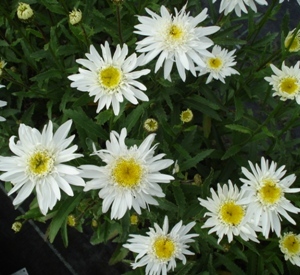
xmin=153 ymin=237 xmax=176 ymax=260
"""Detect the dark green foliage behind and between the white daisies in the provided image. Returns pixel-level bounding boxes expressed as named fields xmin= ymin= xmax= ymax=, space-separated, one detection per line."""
xmin=0 ymin=0 xmax=300 ymax=275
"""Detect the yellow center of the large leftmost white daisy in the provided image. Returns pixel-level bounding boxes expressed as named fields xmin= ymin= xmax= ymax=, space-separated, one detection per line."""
xmin=28 ymin=150 xmax=54 ymax=177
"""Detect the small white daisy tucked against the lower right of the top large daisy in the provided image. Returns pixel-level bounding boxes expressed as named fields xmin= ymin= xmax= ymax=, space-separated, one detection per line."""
xmin=199 ymin=45 xmax=239 ymax=84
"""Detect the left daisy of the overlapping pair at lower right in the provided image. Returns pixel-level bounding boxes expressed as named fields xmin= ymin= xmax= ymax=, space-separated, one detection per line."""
xmin=198 ymin=180 xmax=259 ymax=243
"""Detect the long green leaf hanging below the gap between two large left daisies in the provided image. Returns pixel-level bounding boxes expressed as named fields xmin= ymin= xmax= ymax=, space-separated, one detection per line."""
xmin=48 ymin=192 xmax=84 ymax=243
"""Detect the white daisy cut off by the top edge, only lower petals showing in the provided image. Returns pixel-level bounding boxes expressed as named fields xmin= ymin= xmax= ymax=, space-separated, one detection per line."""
xmin=213 ymin=0 xmax=268 ymax=17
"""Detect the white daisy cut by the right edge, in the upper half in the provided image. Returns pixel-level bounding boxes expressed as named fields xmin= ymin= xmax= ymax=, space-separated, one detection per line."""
xmin=265 ymin=61 xmax=300 ymax=104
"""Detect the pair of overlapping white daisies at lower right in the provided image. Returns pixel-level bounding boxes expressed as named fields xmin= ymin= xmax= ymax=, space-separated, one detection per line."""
xmin=199 ymin=157 xmax=300 ymax=242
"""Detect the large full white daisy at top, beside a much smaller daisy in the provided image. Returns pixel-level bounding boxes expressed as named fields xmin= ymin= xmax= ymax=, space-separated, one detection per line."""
xmin=135 ymin=5 xmax=220 ymax=81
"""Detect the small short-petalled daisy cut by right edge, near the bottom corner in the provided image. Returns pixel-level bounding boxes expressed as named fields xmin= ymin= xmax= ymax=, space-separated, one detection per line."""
xmin=279 ymin=232 xmax=300 ymax=266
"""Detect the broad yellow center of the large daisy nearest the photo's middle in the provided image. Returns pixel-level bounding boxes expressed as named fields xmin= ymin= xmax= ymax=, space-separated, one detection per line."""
xmin=112 ymin=158 xmax=143 ymax=188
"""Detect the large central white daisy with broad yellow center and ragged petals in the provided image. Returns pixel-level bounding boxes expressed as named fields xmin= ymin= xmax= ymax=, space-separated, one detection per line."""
xmin=80 ymin=128 xmax=174 ymax=219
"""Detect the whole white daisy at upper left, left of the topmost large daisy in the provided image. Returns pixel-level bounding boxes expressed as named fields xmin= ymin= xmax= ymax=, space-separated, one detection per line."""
xmin=68 ymin=42 xmax=150 ymax=115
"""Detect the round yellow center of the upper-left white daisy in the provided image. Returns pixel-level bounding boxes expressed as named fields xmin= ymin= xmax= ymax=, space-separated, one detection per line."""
xmin=99 ymin=66 xmax=122 ymax=89
